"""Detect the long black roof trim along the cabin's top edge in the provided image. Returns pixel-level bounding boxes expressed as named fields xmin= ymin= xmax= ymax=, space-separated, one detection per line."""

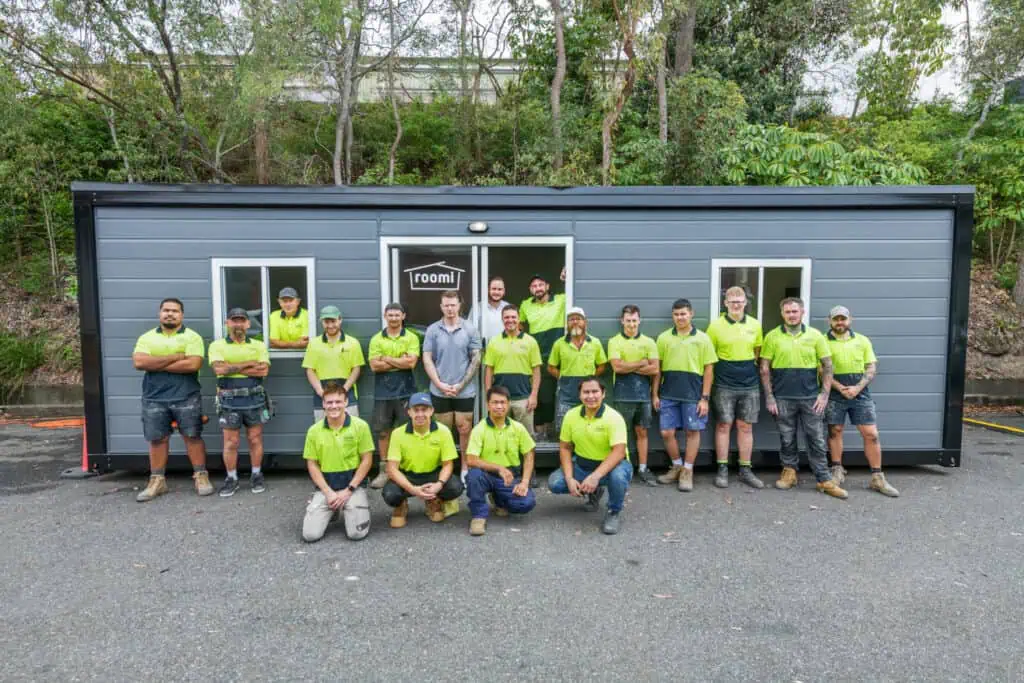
xmin=72 ymin=182 xmax=974 ymax=209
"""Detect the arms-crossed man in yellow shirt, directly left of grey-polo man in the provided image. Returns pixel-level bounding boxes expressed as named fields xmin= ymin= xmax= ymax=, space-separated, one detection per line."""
xmin=368 ymin=303 xmax=419 ymax=488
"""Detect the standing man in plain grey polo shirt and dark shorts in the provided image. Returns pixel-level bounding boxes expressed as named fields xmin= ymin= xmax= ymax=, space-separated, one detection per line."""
xmin=423 ymin=290 xmax=481 ymax=482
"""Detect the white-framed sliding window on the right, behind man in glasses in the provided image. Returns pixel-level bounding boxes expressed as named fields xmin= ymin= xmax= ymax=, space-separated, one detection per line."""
xmin=711 ymin=258 xmax=811 ymax=332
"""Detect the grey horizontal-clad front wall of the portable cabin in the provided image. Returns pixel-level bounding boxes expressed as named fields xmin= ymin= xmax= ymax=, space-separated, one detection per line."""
xmin=95 ymin=207 xmax=953 ymax=453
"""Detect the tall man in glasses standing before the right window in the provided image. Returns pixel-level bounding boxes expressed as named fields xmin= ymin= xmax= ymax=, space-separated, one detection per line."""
xmin=708 ymin=287 xmax=765 ymax=488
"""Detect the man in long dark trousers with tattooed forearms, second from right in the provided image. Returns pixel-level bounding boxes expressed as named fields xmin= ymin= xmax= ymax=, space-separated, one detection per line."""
xmin=761 ymin=297 xmax=847 ymax=499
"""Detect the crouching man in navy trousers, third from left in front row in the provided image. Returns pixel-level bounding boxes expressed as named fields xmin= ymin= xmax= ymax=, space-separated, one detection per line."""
xmin=466 ymin=386 xmax=537 ymax=536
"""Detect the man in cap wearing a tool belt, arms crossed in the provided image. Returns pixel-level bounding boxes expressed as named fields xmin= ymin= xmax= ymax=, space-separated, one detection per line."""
xmin=209 ymin=308 xmax=270 ymax=498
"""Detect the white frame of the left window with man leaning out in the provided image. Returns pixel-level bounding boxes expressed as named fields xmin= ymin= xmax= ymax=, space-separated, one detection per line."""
xmin=210 ymin=258 xmax=316 ymax=358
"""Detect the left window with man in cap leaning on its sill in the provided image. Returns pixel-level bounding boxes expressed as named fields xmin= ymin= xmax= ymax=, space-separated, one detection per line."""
xmin=213 ymin=258 xmax=316 ymax=358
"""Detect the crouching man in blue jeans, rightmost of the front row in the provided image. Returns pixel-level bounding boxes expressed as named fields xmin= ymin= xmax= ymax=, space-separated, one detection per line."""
xmin=548 ymin=377 xmax=633 ymax=533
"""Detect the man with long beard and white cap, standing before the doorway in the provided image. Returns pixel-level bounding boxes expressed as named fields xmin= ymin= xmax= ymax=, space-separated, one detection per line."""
xmin=548 ymin=306 xmax=608 ymax=433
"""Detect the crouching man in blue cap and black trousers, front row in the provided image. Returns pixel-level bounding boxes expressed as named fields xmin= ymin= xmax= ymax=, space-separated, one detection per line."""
xmin=382 ymin=392 xmax=463 ymax=528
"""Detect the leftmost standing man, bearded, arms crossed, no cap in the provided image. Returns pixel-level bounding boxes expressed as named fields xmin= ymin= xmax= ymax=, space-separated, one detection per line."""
xmin=131 ymin=299 xmax=213 ymax=503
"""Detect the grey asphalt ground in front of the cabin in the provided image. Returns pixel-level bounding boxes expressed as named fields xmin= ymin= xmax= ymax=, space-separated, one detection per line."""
xmin=0 ymin=425 xmax=1024 ymax=683
